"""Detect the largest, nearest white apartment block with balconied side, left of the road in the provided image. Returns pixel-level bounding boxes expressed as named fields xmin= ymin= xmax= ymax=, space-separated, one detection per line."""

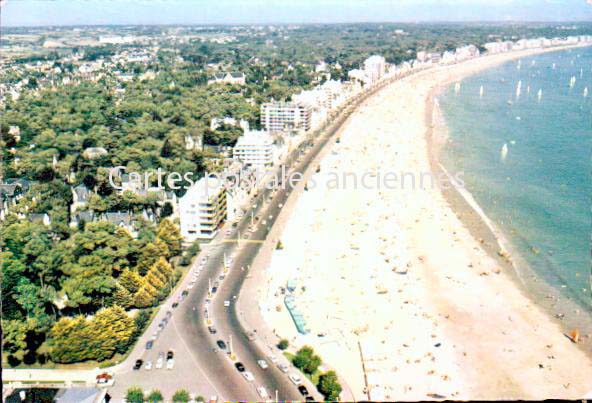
xmin=179 ymin=177 xmax=227 ymax=242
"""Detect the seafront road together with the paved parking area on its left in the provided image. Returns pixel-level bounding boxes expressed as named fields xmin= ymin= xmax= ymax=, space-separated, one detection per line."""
xmin=111 ymin=68 xmax=410 ymax=401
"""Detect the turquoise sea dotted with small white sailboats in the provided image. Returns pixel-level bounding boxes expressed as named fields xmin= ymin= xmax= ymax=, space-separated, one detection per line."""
xmin=438 ymin=47 xmax=592 ymax=312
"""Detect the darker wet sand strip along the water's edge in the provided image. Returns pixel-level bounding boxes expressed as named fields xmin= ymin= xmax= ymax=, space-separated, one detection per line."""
xmin=426 ymin=48 xmax=592 ymax=358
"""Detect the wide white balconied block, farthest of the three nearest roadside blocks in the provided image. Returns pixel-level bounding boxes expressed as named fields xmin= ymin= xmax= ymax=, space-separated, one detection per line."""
xmin=261 ymin=102 xmax=312 ymax=132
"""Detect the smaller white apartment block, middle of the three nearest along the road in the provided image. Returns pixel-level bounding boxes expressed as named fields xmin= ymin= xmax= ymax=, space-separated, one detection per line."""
xmin=234 ymin=130 xmax=274 ymax=168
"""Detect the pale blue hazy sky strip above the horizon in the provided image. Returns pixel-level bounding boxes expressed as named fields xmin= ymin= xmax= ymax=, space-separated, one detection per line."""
xmin=0 ymin=0 xmax=592 ymax=26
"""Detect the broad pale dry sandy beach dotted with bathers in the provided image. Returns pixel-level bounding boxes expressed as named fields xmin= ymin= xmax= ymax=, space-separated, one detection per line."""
xmin=259 ymin=46 xmax=592 ymax=400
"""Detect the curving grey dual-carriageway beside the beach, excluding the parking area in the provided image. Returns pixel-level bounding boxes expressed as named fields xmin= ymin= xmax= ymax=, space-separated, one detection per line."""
xmin=169 ymin=69 xmax=416 ymax=401
